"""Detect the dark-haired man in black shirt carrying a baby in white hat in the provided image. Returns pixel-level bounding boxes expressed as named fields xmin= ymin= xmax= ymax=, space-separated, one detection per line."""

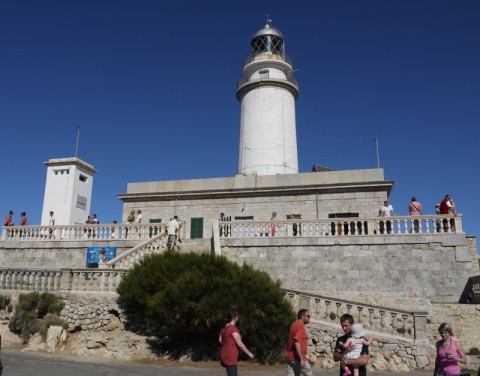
xmin=333 ymin=313 xmax=368 ymax=376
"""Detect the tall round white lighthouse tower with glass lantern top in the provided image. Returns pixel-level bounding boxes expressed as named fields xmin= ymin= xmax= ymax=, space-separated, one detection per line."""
xmin=237 ymin=18 xmax=299 ymax=175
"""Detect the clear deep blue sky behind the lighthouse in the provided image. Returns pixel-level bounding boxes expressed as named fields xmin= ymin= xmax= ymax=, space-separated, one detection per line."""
xmin=0 ymin=0 xmax=480 ymax=235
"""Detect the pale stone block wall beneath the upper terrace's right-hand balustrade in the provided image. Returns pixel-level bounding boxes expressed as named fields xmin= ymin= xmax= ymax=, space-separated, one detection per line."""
xmin=222 ymin=234 xmax=478 ymax=309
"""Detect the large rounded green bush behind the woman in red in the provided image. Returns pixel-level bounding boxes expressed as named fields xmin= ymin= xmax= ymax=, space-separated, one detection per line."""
xmin=118 ymin=252 xmax=295 ymax=363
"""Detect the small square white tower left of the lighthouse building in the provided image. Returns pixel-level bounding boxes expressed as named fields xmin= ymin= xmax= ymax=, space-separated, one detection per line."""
xmin=41 ymin=158 xmax=97 ymax=226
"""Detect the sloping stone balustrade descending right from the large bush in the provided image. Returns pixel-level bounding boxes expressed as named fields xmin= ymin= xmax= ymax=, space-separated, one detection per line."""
xmin=285 ymin=290 xmax=427 ymax=341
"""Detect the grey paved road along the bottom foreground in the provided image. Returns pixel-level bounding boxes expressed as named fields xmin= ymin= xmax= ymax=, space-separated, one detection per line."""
xmin=2 ymin=350 xmax=431 ymax=376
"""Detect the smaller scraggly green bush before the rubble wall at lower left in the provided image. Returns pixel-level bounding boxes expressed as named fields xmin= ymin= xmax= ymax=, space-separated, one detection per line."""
xmin=8 ymin=292 xmax=64 ymax=343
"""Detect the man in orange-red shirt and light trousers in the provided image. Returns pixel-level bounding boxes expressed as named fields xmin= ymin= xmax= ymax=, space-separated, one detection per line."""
xmin=286 ymin=309 xmax=313 ymax=376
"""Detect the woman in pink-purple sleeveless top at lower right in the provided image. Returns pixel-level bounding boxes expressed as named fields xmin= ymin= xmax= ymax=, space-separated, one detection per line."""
xmin=433 ymin=322 xmax=467 ymax=376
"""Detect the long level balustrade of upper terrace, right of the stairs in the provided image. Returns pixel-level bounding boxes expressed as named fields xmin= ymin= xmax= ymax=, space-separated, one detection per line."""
xmin=218 ymin=215 xmax=463 ymax=238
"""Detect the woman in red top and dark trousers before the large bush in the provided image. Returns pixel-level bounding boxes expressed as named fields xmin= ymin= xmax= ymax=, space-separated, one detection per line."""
xmin=218 ymin=312 xmax=255 ymax=376
